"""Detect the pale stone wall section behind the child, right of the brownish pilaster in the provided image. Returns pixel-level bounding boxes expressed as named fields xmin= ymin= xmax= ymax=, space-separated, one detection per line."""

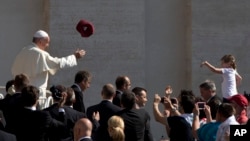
xmin=192 ymin=0 xmax=250 ymax=96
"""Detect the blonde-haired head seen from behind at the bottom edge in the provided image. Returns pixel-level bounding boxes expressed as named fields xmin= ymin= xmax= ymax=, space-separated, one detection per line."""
xmin=108 ymin=116 xmax=125 ymax=141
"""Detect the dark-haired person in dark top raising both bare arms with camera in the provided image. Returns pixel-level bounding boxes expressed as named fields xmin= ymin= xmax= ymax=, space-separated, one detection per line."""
xmin=153 ymin=90 xmax=195 ymax=141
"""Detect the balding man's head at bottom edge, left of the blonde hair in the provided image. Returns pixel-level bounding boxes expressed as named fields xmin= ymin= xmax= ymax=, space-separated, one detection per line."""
xmin=74 ymin=118 xmax=94 ymax=141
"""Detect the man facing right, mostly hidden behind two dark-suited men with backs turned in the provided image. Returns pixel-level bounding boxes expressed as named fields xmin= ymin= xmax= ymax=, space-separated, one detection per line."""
xmin=113 ymin=76 xmax=131 ymax=107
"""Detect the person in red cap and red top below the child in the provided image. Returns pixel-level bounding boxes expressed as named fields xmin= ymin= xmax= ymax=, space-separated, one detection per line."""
xmin=229 ymin=94 xmax=248 ymax=124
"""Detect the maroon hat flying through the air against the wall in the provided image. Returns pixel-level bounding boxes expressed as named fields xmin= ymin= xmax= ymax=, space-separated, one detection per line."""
xmin=76 ymin=19 xmax=95 ymax=37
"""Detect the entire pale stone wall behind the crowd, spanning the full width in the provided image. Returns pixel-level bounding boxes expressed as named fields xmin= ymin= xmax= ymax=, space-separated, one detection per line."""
xmin=0 ymin=0 xmax=250 ymax=141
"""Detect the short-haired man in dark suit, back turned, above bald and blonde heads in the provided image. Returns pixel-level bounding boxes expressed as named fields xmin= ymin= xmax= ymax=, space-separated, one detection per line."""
xmin=87 ymin=84 xmax=121 ymax=141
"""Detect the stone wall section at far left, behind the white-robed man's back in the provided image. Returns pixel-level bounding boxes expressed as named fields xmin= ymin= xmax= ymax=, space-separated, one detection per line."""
xmin=0 ymin=0 xmax=47 ymax=92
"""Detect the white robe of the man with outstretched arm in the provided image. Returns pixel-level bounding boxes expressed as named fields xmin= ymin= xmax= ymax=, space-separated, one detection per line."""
xmin=11 ymin=43 xmax=77 ymax=97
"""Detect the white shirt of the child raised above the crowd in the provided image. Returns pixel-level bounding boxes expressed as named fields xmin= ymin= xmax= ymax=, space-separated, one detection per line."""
xmin=221 ymin=68 xmax=238 ymax=99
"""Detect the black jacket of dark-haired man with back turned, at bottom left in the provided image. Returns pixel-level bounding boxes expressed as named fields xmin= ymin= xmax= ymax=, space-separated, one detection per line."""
xmin=16 ymin=108 xmax=68 ymax=141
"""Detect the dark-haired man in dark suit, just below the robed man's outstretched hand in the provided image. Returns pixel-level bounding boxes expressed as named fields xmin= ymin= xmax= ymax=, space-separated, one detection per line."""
xmin=71 ymin=71 xmax=91 ymax=113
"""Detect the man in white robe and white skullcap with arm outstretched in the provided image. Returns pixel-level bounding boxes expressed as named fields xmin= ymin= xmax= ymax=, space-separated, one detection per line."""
xmin=11 ymin=30 xmax=86 ymax=107
